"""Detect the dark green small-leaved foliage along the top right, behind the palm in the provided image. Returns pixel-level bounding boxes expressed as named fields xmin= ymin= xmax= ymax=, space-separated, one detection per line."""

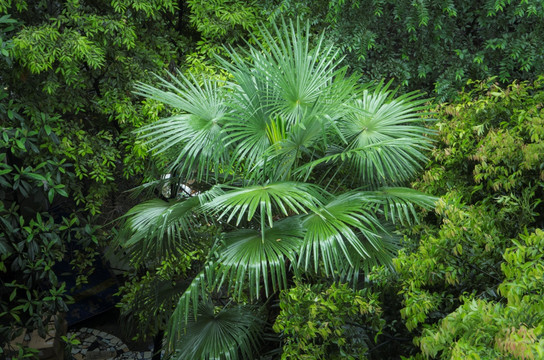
xmin=265 ymin=0 xmax=544 ymax=99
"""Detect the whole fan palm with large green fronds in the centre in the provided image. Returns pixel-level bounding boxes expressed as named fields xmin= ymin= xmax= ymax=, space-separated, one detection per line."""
xmin=120 ymin=19 xmax=433 ymax=359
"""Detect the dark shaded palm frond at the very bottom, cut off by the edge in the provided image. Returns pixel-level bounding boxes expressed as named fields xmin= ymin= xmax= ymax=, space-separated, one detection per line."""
xmin=172 ymin=302 xmax=263 ymax=360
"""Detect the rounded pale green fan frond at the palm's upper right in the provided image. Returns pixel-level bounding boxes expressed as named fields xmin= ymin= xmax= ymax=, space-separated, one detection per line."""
xmin=338 ymin=83 xmax=430 ymax=184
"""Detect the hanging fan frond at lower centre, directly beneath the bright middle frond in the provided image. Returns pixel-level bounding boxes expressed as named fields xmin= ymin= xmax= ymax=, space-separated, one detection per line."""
xmin=218 ymin=217 xmax=303 ymax=298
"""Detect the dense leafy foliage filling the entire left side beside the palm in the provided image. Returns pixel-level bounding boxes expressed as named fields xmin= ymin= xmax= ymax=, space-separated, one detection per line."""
xmin=0 ymin=0 xmax=193 ymax=353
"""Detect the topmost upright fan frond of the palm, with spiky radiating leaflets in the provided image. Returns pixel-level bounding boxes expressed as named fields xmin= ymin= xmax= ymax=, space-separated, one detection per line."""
xmin=220 ymin=22 xmax=356 ymax=126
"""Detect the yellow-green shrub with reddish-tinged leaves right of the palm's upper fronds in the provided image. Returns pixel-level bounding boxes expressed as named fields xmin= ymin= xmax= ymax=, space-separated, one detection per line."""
xmin=416 ymin=77 xmax=544 ymax=231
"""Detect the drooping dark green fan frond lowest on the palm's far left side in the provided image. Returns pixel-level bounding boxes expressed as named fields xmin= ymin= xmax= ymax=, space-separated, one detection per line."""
xmin=117 ymin=197 xmax=200 ymax=258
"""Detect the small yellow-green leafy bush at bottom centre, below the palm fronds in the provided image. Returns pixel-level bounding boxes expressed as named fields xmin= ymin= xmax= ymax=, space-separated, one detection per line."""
xmin=274 ymin=283 xmax=383 ymax=359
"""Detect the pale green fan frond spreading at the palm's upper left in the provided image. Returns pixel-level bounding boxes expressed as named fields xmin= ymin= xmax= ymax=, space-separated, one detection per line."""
xmin=136 ymin=73 xmax=232 ymax=179
